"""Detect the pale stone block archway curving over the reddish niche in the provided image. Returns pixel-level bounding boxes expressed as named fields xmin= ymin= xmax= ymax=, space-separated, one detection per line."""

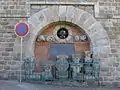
xmin=25 ymin=6 xmax=111 ymax=58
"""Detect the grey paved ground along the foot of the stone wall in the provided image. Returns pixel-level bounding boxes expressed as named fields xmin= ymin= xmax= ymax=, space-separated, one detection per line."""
xmin=0 ymin=80 xmax=120 ymax=90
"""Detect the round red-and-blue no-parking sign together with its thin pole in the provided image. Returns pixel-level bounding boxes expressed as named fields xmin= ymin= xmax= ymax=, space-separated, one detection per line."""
xmin=15 ymin=22 xmax=29 ymax=83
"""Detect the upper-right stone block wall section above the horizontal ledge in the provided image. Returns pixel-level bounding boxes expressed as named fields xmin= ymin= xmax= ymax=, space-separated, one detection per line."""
xmin=98 ymin=0 xmax=120 ymax=18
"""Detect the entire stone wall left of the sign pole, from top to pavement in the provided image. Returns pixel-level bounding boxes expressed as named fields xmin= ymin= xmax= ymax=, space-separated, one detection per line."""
xmin=0 ymin=0 xmax=30 ymax=79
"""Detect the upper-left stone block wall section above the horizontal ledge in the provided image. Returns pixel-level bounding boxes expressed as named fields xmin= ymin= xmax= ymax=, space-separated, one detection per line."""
xmin=0 ymin=0 xmax=29 ymax=17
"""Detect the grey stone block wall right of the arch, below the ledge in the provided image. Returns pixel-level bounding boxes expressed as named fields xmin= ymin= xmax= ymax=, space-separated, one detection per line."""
xmin=97 ymin=18 xmax=120 ymax=85
